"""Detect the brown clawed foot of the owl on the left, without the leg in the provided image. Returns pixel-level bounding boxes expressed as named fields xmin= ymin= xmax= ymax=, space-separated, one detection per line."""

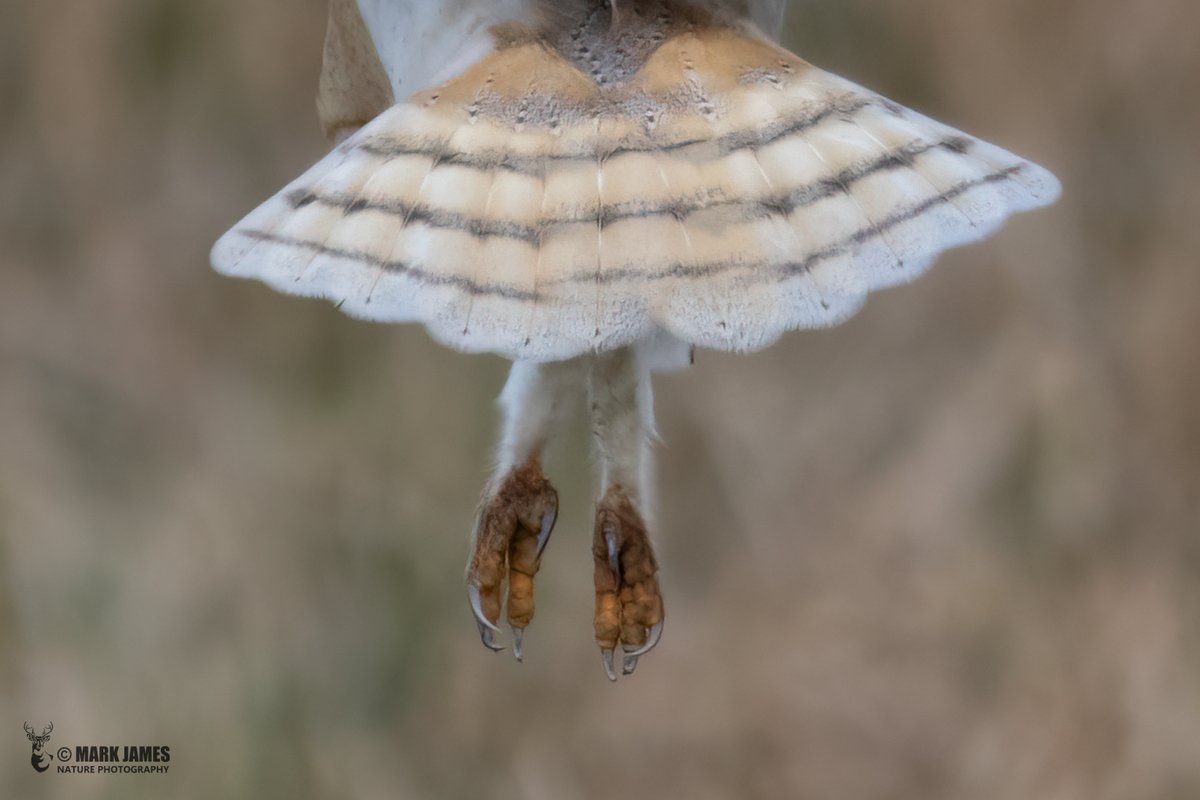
xmin=467 ymin=458 xmax=558 ymax=661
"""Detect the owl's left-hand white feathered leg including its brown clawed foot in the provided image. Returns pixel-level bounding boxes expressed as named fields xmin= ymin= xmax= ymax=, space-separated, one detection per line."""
xmin=467 ymin=361 xmax=582 ymax=661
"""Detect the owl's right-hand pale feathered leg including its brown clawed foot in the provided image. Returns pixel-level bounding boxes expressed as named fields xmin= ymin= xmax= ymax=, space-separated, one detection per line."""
xmin=588 ymin=349 xmax=664 ymax=680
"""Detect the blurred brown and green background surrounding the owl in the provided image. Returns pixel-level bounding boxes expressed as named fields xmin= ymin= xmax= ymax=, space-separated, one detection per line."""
xmin=0 ymin=0 xmax=1200 ymax=800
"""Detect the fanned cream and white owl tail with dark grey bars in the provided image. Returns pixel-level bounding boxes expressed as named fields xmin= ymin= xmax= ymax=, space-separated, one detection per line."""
xmin=212 ymin=0 xmax=1060 ymax=360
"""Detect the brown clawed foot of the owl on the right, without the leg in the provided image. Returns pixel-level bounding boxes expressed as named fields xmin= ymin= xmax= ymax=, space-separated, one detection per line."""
xmin=592 ymin=487 xmax=664 ymax=680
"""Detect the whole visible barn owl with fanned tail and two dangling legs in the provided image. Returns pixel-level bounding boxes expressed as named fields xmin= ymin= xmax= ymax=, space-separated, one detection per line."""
xmin=212 ymin=0 xmax=1060 ymax=680
